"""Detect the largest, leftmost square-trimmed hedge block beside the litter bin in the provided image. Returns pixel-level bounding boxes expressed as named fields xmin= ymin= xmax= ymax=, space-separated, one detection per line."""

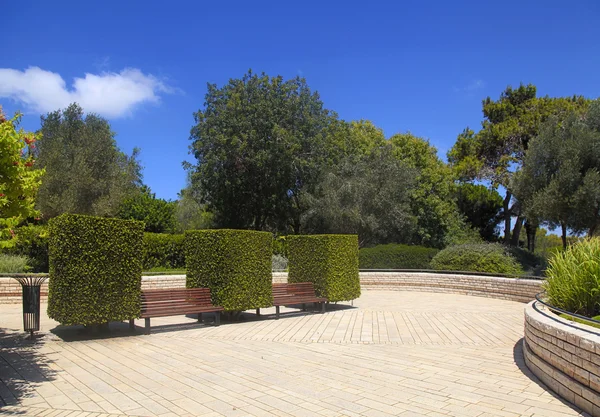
xmin=48 ymin=214 xmax=144 ymax=325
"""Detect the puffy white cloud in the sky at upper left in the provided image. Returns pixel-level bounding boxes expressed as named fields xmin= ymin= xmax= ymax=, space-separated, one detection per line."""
xmin=0 ymin=67 xmax=174 ymax=118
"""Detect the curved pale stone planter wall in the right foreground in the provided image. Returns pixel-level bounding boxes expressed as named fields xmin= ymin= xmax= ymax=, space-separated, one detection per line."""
xmin=523 ymin=301 xmax=600 ymax=417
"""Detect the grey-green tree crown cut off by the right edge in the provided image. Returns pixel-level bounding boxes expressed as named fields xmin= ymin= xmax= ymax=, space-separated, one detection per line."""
xmin=512 ymin=100 xmax=600 ymax=248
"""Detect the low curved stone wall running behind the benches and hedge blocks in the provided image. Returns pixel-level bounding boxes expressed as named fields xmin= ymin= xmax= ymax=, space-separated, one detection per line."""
xmin=0 ymin=271 xmax=542 ymax=303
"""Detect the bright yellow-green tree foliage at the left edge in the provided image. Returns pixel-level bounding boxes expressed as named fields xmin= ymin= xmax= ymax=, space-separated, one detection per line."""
xmin=0 ymin=106 xmax=44 ymax=248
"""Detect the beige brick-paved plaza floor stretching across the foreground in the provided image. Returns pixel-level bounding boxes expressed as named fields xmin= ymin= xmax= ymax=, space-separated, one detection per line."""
xmin=0 ymin=291 xmax=584 ymax=417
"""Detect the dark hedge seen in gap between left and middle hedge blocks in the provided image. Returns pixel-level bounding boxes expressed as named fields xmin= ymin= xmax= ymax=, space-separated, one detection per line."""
xmin=142 ymin=233 xmax=185 ymax=271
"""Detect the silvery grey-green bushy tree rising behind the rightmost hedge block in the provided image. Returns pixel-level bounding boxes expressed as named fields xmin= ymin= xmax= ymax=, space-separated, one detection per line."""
xmin=304 ymin=146 xmax=417 ymax=246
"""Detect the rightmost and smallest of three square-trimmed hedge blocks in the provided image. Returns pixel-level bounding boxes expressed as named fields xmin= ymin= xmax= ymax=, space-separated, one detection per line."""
xmin=287 ymin=235 xmax=360 ymax=301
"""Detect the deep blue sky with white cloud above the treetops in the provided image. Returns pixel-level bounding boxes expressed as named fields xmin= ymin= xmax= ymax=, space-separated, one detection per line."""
xmin=0 ymin=0 xmax=600 ymax=199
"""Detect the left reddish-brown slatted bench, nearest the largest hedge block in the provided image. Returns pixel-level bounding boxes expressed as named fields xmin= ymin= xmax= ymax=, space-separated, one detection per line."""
xmin=129 ymin=288 xmax=223 ymax=334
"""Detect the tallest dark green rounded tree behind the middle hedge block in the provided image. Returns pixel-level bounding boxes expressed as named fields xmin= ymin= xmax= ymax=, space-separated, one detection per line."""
xmin=188 ymin=71 xmax=335 ymax=233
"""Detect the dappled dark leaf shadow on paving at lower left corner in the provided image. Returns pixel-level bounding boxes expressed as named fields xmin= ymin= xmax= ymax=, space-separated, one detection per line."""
xmin=0 ymin=328 xmax=56 ymax=415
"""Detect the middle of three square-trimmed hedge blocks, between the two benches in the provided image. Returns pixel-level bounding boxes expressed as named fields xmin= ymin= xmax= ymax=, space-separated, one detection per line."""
xmin=185 ymin=229 xmax=273 ymax=311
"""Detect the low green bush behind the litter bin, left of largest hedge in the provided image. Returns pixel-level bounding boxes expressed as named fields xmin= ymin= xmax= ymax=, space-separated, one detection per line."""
xmin=3 ymin=225 xmax=48 ymax=272
